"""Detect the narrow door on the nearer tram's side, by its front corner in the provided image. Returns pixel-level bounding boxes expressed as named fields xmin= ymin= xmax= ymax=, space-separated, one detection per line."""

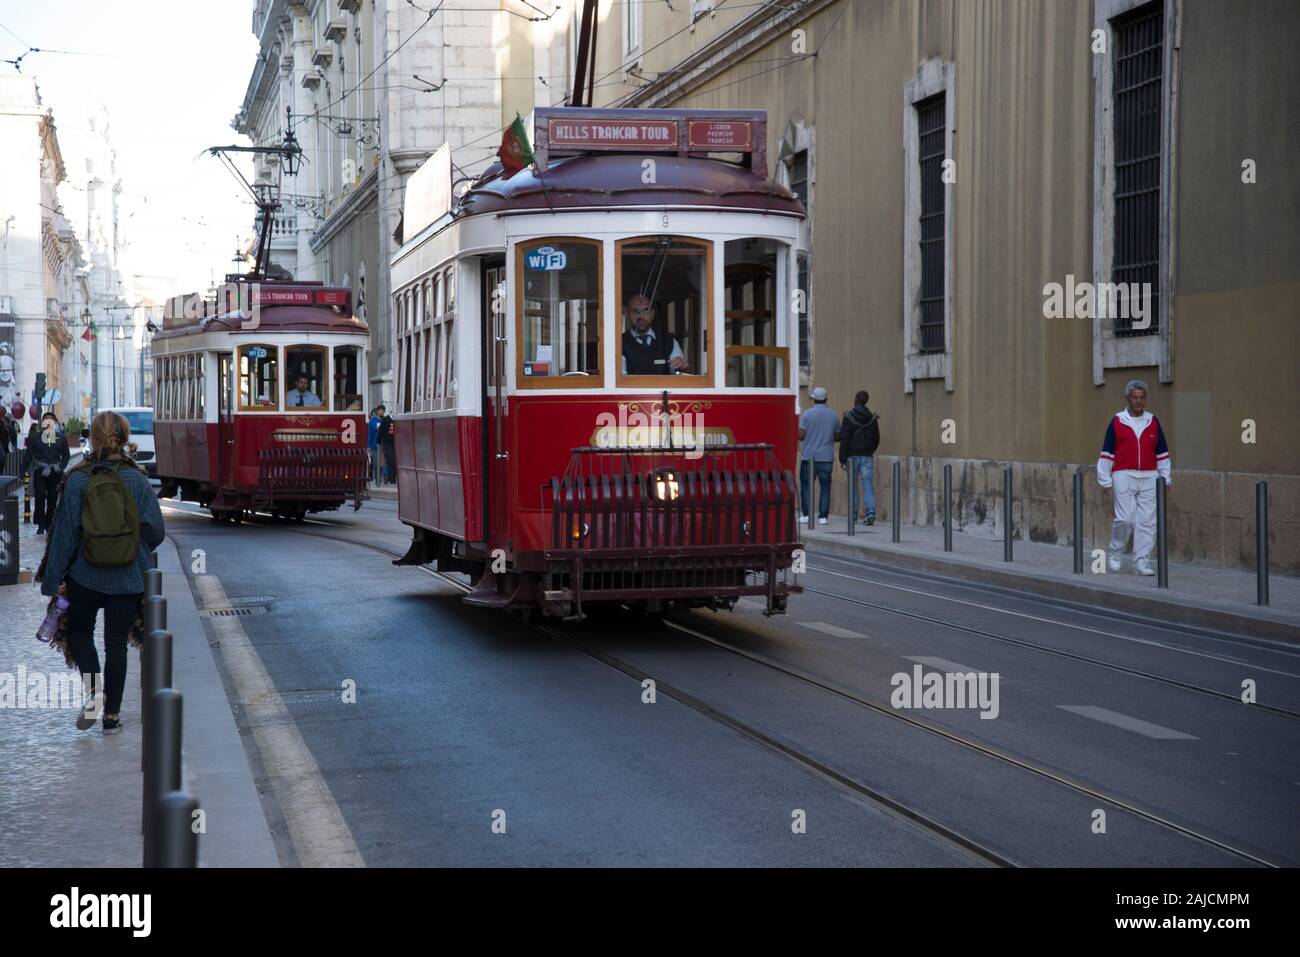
xmin=480 ymin=256 xmax=510 ymax=542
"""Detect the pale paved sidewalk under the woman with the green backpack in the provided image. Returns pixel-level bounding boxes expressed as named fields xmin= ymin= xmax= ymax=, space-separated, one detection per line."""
xmin=0 ymin=514 xmax=278 ymax=867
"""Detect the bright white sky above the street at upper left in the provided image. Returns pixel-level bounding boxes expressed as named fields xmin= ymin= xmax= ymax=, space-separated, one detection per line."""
xmin=0 ymin=0 xmax=257 ymax=293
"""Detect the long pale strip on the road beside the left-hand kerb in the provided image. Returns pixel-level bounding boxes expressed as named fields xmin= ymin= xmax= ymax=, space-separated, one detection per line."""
xmin=194 ymin=575 xmax=365 ymax=867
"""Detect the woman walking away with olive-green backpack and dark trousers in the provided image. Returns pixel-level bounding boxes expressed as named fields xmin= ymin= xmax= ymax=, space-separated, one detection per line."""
xmin=40 ymin=412 xmax=164 ymax=735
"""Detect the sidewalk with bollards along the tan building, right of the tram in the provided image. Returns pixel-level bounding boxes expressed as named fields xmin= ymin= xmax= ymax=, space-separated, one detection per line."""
xmin=801 ymin=515 xmax=1300 ymax=642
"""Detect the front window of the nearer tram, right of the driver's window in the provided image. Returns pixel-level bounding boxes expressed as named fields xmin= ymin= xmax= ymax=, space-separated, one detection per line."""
xmin=723 ymin=238 xmax=790 ymax=389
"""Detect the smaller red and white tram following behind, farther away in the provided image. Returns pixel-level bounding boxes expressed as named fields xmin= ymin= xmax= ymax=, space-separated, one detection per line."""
xmin=152 ymin=281 xmax=369 ymax=521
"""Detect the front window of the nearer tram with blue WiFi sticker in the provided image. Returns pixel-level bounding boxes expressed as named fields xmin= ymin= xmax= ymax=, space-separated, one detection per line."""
xmin=517 ymin=239 xmax=601 ymax=378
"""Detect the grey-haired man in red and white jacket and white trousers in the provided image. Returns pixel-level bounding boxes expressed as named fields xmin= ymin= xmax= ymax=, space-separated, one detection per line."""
xmin=1097 ymin=378 xmax=1171 ymax=575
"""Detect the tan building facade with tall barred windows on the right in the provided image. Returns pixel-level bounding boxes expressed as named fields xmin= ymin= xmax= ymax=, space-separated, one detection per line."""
xmin=595 ymin=0 xmax=1300 ymax=573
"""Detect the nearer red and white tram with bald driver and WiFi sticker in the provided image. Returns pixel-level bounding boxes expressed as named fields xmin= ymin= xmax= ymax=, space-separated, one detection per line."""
xmin=391 ymin=107 xmax=805 ymax=619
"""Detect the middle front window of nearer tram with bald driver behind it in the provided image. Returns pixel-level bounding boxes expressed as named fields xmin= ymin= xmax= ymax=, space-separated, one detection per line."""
xmin=618 ymin=235 xmax=712 ymax=376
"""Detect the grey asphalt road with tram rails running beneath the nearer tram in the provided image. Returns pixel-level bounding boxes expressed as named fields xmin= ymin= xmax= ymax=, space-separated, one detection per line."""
xmin=166 ymin=502 xmax=1300 ymax=866
